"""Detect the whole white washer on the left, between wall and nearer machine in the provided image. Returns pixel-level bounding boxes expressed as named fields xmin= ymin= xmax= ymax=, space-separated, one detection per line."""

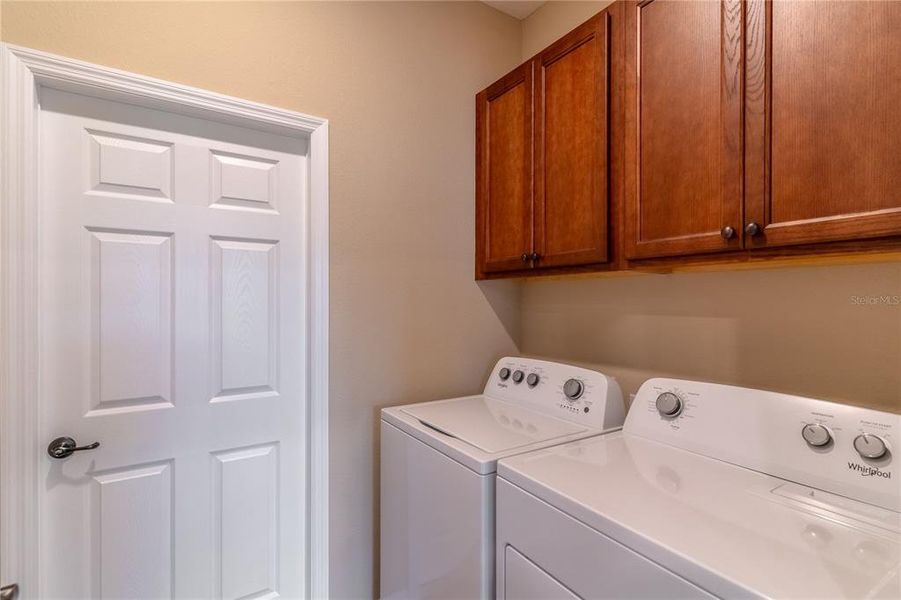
xmin=381 ymin=358 xmax=625 ymax=599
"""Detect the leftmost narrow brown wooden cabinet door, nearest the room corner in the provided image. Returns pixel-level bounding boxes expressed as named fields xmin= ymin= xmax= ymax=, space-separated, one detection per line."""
xmin=476 ymin=63 xmax=533 ymax=277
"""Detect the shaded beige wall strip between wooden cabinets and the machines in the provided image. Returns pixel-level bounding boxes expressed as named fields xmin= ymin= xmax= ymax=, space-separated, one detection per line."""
xmin=520 ymin=262 xmax=901 ymax=412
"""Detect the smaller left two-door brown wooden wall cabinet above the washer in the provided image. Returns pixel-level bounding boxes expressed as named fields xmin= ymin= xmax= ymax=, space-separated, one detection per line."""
xmin=476 ymin=5 xmax=622 ymax=278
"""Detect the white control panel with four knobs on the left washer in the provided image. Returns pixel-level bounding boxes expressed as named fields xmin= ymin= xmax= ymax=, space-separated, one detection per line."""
xmin=485 ymin=357 xmax=625 ymax=429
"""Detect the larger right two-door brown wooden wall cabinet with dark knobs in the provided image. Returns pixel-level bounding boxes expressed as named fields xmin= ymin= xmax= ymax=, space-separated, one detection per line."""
xmin=624 ymin=0 xmax=901 ymax=264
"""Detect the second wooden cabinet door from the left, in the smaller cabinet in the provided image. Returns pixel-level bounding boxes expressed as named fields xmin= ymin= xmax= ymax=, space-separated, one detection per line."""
xmin=535 ymin=12 xmax=620 ymax=267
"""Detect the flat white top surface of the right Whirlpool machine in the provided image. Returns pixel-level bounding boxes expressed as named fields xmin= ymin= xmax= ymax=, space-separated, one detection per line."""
xmin=497 ymin=434 xmax=901 ymax=598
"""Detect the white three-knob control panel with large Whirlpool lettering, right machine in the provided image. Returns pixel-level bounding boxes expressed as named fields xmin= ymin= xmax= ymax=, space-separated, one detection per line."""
xmin=623 ymin=378 xmax=901 ymax=512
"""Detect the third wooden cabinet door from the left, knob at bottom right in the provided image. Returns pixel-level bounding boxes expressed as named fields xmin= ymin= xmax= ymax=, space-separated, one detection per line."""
xmin=625 ymin=0 xmax=743 ymax=258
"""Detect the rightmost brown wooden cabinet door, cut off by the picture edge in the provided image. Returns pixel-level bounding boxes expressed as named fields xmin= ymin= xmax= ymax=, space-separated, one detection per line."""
xmin=745 ymin=0 xmax=901 ymax=247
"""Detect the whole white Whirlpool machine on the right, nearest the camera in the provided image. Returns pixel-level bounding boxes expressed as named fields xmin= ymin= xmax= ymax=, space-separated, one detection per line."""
xmin=496 ymin=379 xmax=901 ymax=600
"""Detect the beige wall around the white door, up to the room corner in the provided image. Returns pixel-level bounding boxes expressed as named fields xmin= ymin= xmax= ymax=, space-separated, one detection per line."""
xmin=0 ymin=2 xmax=521 ymax=598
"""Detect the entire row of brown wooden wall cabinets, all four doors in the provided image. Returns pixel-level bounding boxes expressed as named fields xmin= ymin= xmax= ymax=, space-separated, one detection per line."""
xmin=476 ymin=0 xmax=901 ymax=278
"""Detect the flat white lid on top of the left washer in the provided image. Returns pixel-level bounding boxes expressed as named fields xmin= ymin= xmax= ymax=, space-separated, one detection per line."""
xmin=401 ymin=396 xmax=587 ymax=454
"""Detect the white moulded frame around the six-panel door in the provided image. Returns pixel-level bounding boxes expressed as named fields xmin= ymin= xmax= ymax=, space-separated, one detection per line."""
xmin=0 ymin=44 xmax=328 ymax=598
